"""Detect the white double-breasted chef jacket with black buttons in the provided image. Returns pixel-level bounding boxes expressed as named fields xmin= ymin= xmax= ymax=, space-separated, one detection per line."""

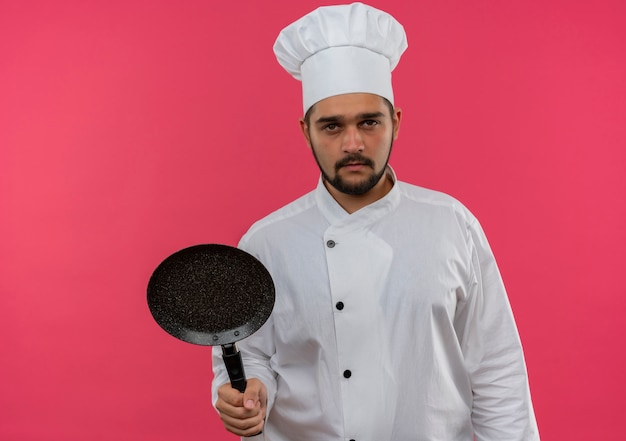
xmin=213 ymin=169 xmax=539 ymax=441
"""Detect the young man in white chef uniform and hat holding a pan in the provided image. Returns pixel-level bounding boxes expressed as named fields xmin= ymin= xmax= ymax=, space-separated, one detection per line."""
xmin=213 ymin=3 xmax=539 ymax=441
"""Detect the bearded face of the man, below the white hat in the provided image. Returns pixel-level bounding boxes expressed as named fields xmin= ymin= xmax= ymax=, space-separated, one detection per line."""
xmin=300 ymin=93 xmax=401 ymax=196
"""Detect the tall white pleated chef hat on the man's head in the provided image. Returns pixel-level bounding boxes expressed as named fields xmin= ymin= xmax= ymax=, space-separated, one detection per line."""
xmin=274 ymin=3 xmax=407 ymax=113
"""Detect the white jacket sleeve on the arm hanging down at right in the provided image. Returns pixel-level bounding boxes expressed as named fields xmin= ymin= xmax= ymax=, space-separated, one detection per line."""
xmin=455 ymin=217 xmax=539 ymax=441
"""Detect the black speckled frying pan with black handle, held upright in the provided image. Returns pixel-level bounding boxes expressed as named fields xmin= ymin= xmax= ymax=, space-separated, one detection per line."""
xmin=148 ymin=244 xmax=275 ymax=392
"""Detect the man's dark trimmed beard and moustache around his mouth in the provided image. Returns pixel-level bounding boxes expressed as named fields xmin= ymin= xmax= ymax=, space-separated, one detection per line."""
xmin=311 ymin=141 xmax=393 ymax=196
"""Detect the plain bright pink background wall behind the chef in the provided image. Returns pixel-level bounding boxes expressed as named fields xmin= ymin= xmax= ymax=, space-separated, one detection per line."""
xmin=0 ymin=0 xmax=626 ymax=441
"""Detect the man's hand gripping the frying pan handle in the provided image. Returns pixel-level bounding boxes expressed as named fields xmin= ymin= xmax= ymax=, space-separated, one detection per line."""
xmin=215 ymin=378 xmax=267 ymax=437
